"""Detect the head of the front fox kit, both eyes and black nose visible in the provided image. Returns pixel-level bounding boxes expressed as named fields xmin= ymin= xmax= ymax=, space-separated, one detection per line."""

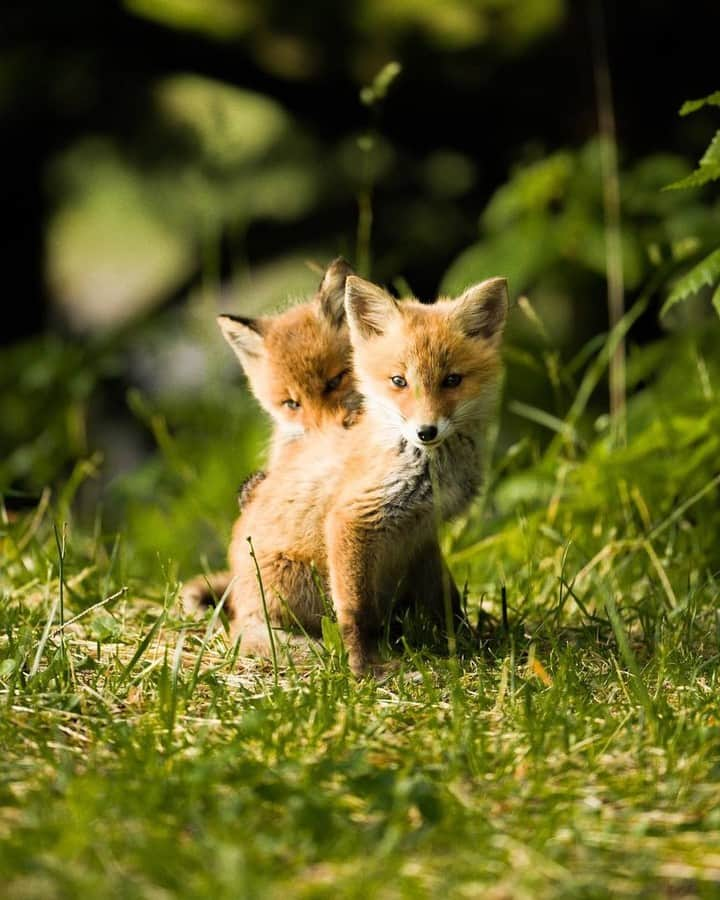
xmin=345 ymin=276 xmax=508 ymax=450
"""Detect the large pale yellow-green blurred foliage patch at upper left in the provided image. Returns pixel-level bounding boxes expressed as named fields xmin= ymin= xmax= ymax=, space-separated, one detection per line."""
xmin=47 ymin=75 xmax=319 ymax=330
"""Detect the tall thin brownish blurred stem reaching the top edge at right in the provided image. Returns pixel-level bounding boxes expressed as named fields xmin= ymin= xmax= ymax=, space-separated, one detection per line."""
xmin=590 ymin=0 xmax=627 ymax=444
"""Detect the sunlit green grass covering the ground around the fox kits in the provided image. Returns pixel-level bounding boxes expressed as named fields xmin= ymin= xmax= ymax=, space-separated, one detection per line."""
xmin=0 ymin=322 xmax=720 ymax=898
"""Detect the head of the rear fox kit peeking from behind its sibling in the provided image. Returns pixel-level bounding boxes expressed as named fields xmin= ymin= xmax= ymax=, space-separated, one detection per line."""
xmin=218 ymin=259 xmax=359 ymax=438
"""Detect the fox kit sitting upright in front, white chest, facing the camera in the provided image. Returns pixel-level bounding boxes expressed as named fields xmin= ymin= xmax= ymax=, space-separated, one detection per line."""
xmin=228 ymin=276 xmax=507 ymax=674
